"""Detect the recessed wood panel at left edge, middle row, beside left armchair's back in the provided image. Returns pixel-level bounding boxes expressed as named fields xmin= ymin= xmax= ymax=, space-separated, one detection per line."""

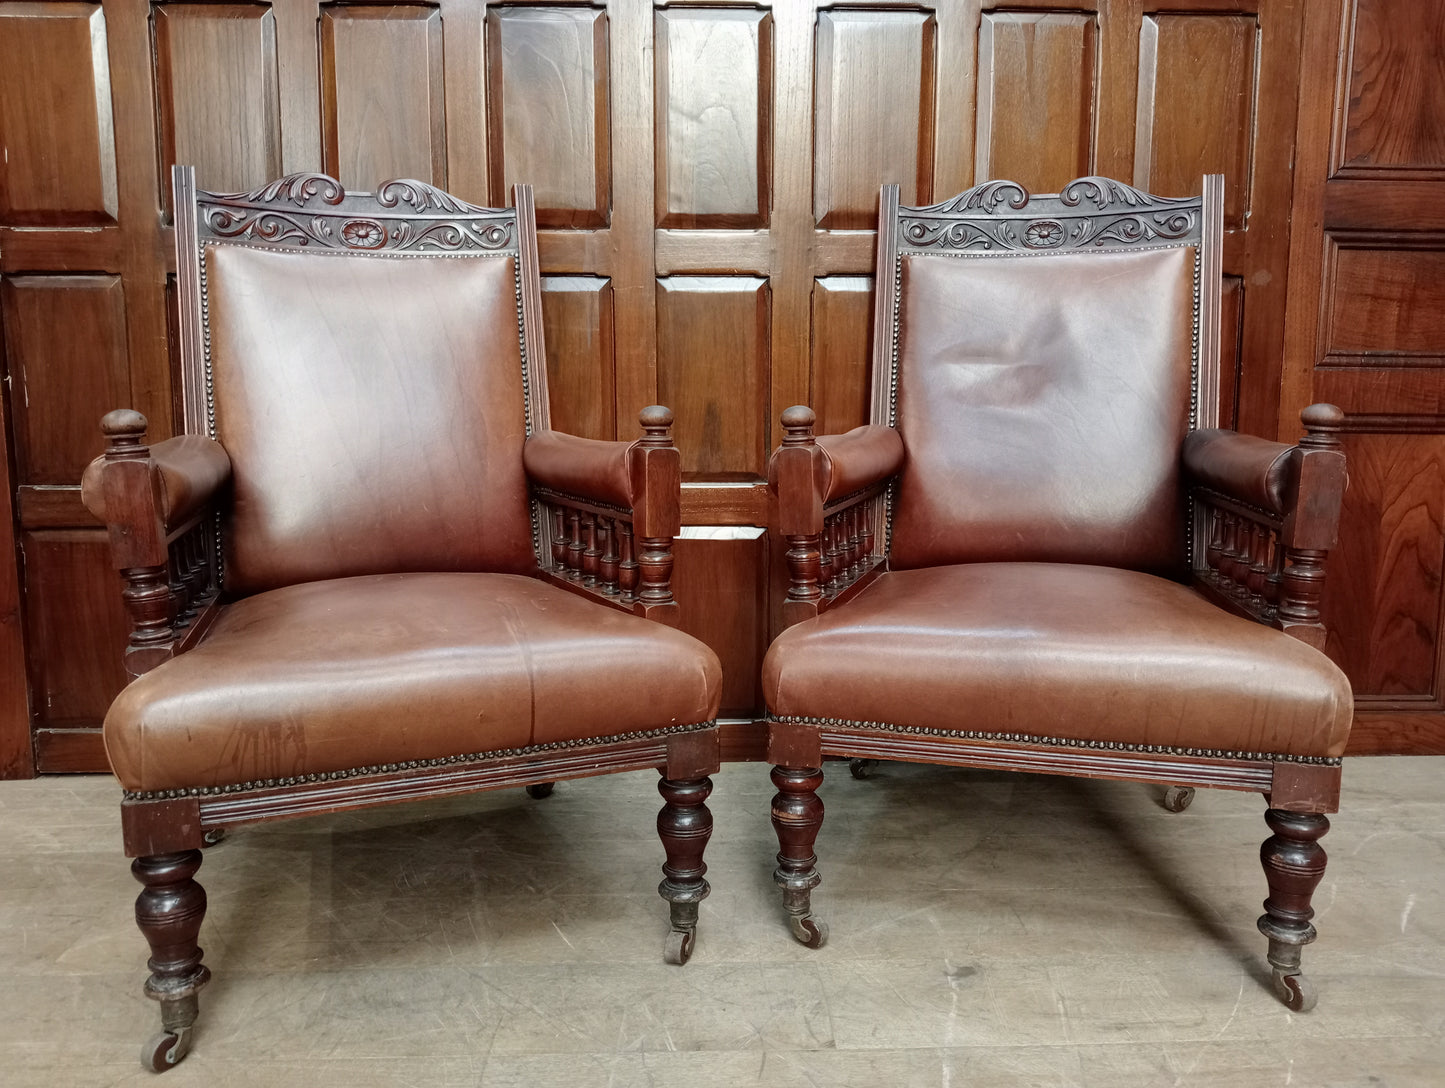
xmin=0 ymin=276 xmax=130 ymax=485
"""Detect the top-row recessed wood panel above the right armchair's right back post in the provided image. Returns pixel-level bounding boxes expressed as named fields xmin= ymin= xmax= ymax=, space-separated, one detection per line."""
xmin=1134 ymin=14 xmax=1259 ymax=228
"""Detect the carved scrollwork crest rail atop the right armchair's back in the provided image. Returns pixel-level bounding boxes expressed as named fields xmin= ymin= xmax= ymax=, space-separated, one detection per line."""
xmin=899 ymin=178 xmax=1201 ymax=253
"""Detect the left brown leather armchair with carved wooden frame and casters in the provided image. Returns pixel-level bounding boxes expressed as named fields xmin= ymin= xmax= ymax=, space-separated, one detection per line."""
xmin=82 ymin=168 xmax=721 ymax=1071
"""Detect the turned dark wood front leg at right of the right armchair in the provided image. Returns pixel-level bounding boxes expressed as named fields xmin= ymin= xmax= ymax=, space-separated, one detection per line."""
xmin=1259 ymin=809 xmax=1329 ymax=1013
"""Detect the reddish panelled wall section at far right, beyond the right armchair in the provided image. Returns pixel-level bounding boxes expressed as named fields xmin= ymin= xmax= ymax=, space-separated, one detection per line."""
xmin=1280 ymin=0 xmax=1445 ymax=753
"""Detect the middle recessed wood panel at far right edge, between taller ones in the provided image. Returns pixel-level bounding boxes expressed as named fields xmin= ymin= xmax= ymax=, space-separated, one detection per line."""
xmin=1325 ymin=247 xmax=1445 ymax=356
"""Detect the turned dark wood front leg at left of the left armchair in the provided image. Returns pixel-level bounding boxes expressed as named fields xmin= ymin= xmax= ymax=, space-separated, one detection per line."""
xmin=130 ymin=850 xmax=211 ymax=1074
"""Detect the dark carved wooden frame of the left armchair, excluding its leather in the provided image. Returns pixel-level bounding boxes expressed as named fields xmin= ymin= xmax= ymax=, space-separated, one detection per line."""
xmin=90 ymin=166 xmax=718 ymax=1071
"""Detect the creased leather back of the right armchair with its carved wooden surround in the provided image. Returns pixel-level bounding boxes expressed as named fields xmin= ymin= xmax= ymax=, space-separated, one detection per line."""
xmin=873 ymin=178 xmax=1222 ymax=574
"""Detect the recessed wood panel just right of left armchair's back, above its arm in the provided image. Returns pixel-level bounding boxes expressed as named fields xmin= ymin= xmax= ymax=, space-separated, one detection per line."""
xmin=542 ymin=276 xmax=612 ymax=439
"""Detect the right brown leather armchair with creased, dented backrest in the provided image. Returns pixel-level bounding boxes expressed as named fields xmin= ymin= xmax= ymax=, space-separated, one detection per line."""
xmin=763 ymin=176 xmax=1351 ymax=1010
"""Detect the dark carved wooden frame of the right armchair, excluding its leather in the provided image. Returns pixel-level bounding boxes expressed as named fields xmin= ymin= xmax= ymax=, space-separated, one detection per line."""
xmin=769 ymin=175 xmax=1345 ymax=1011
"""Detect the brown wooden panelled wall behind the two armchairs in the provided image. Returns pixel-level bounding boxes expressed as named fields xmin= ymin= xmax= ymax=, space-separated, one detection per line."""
xmin=0 ymin=0 xmax=1427 ymax=774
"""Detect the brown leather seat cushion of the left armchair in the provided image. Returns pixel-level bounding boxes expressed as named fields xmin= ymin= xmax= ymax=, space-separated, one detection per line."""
xmin=105 ymin=574 xmax=721 ymax=790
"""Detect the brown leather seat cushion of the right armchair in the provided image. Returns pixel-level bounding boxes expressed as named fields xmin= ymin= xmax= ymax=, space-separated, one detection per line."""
xmin=763 ymin=564 xmax=1351 ymax=756
